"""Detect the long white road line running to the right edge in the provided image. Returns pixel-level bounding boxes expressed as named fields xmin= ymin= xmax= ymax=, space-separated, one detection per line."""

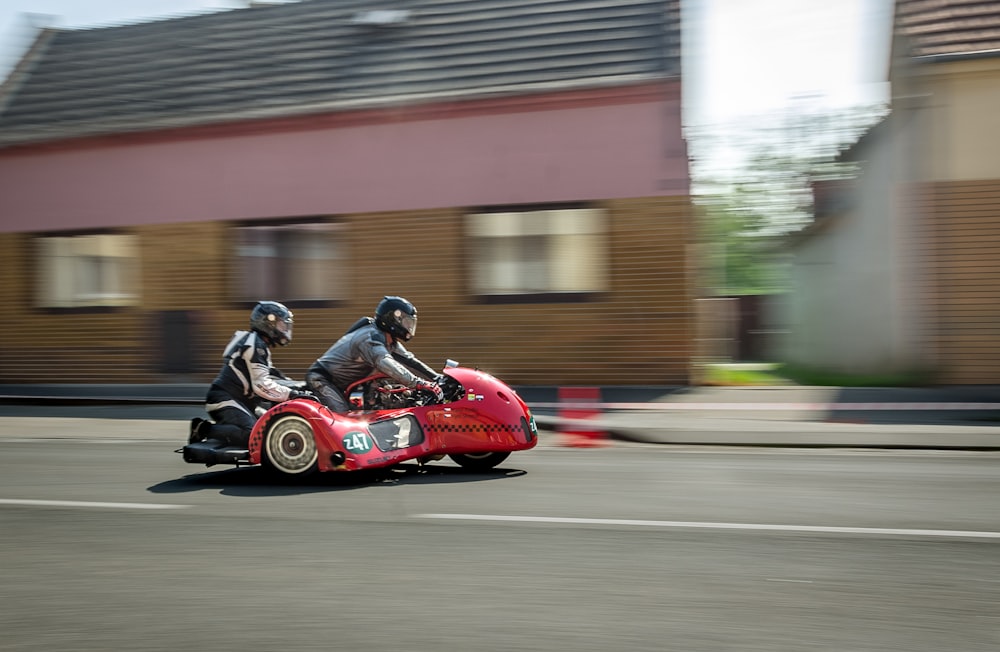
xmin=413 ymin=514 xmax=1000 ymax=539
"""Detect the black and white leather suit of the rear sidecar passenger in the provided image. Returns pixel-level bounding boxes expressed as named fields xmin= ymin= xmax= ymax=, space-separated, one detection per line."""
xmin=205 ymin=331 xmax=291 ymax=446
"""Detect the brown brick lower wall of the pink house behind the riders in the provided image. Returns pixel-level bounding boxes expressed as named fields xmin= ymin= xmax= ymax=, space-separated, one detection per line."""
xmin=0 ymin=197 xmax=694 ymax=385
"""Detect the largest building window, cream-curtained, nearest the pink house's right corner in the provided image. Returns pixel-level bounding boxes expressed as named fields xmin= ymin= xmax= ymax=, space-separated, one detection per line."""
xmin=466 ymin=207 xmax=608 ymax=300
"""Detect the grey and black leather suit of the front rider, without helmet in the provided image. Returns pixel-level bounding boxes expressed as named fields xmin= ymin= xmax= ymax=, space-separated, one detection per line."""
xmin=305 ymin=317 xmax=437 ymax=414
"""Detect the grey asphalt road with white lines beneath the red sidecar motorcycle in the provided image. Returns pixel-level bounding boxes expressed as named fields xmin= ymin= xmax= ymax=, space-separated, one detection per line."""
xmin=0 ymin=418 xmax=1000 ymax=652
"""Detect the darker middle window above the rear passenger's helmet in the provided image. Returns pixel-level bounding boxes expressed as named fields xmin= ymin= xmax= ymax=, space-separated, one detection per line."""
xmin=234 ymin=222 xmax=344 ymax=304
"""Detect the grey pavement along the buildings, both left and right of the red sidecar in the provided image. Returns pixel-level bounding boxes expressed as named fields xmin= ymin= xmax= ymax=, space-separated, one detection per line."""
xmin=0 ymin=384 xmax=1000 ymax=450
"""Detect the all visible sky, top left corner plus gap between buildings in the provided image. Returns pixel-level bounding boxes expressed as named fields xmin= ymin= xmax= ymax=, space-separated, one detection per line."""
xmin=0 ymin=0 xmax=893 ymax=155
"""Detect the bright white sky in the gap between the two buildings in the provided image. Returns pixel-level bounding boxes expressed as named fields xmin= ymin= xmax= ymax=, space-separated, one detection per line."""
xmin=682 ymin=0 xmax=893 ymax=124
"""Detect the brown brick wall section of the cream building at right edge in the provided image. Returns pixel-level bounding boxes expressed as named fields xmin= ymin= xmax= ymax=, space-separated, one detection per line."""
xmin=920 ymin=180 xmax=1000 ymax=385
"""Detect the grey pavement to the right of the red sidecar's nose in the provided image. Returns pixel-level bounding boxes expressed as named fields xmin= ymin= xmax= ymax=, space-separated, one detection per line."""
xmin=539 ymin=386 xmax=1000 ymax=450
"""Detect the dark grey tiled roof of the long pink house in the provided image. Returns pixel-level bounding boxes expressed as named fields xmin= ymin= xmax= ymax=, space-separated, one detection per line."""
xmin=0 ymin=0 xmax=680 ymax=144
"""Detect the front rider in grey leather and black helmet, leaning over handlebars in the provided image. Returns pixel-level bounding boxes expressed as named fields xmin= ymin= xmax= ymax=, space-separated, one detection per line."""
xmin=305 ymin=296 xmax=444 ymax=414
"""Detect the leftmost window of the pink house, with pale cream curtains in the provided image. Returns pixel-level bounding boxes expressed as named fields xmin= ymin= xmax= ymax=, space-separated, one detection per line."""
xmin=37 ymin=233 xmax=139 ymax=308
